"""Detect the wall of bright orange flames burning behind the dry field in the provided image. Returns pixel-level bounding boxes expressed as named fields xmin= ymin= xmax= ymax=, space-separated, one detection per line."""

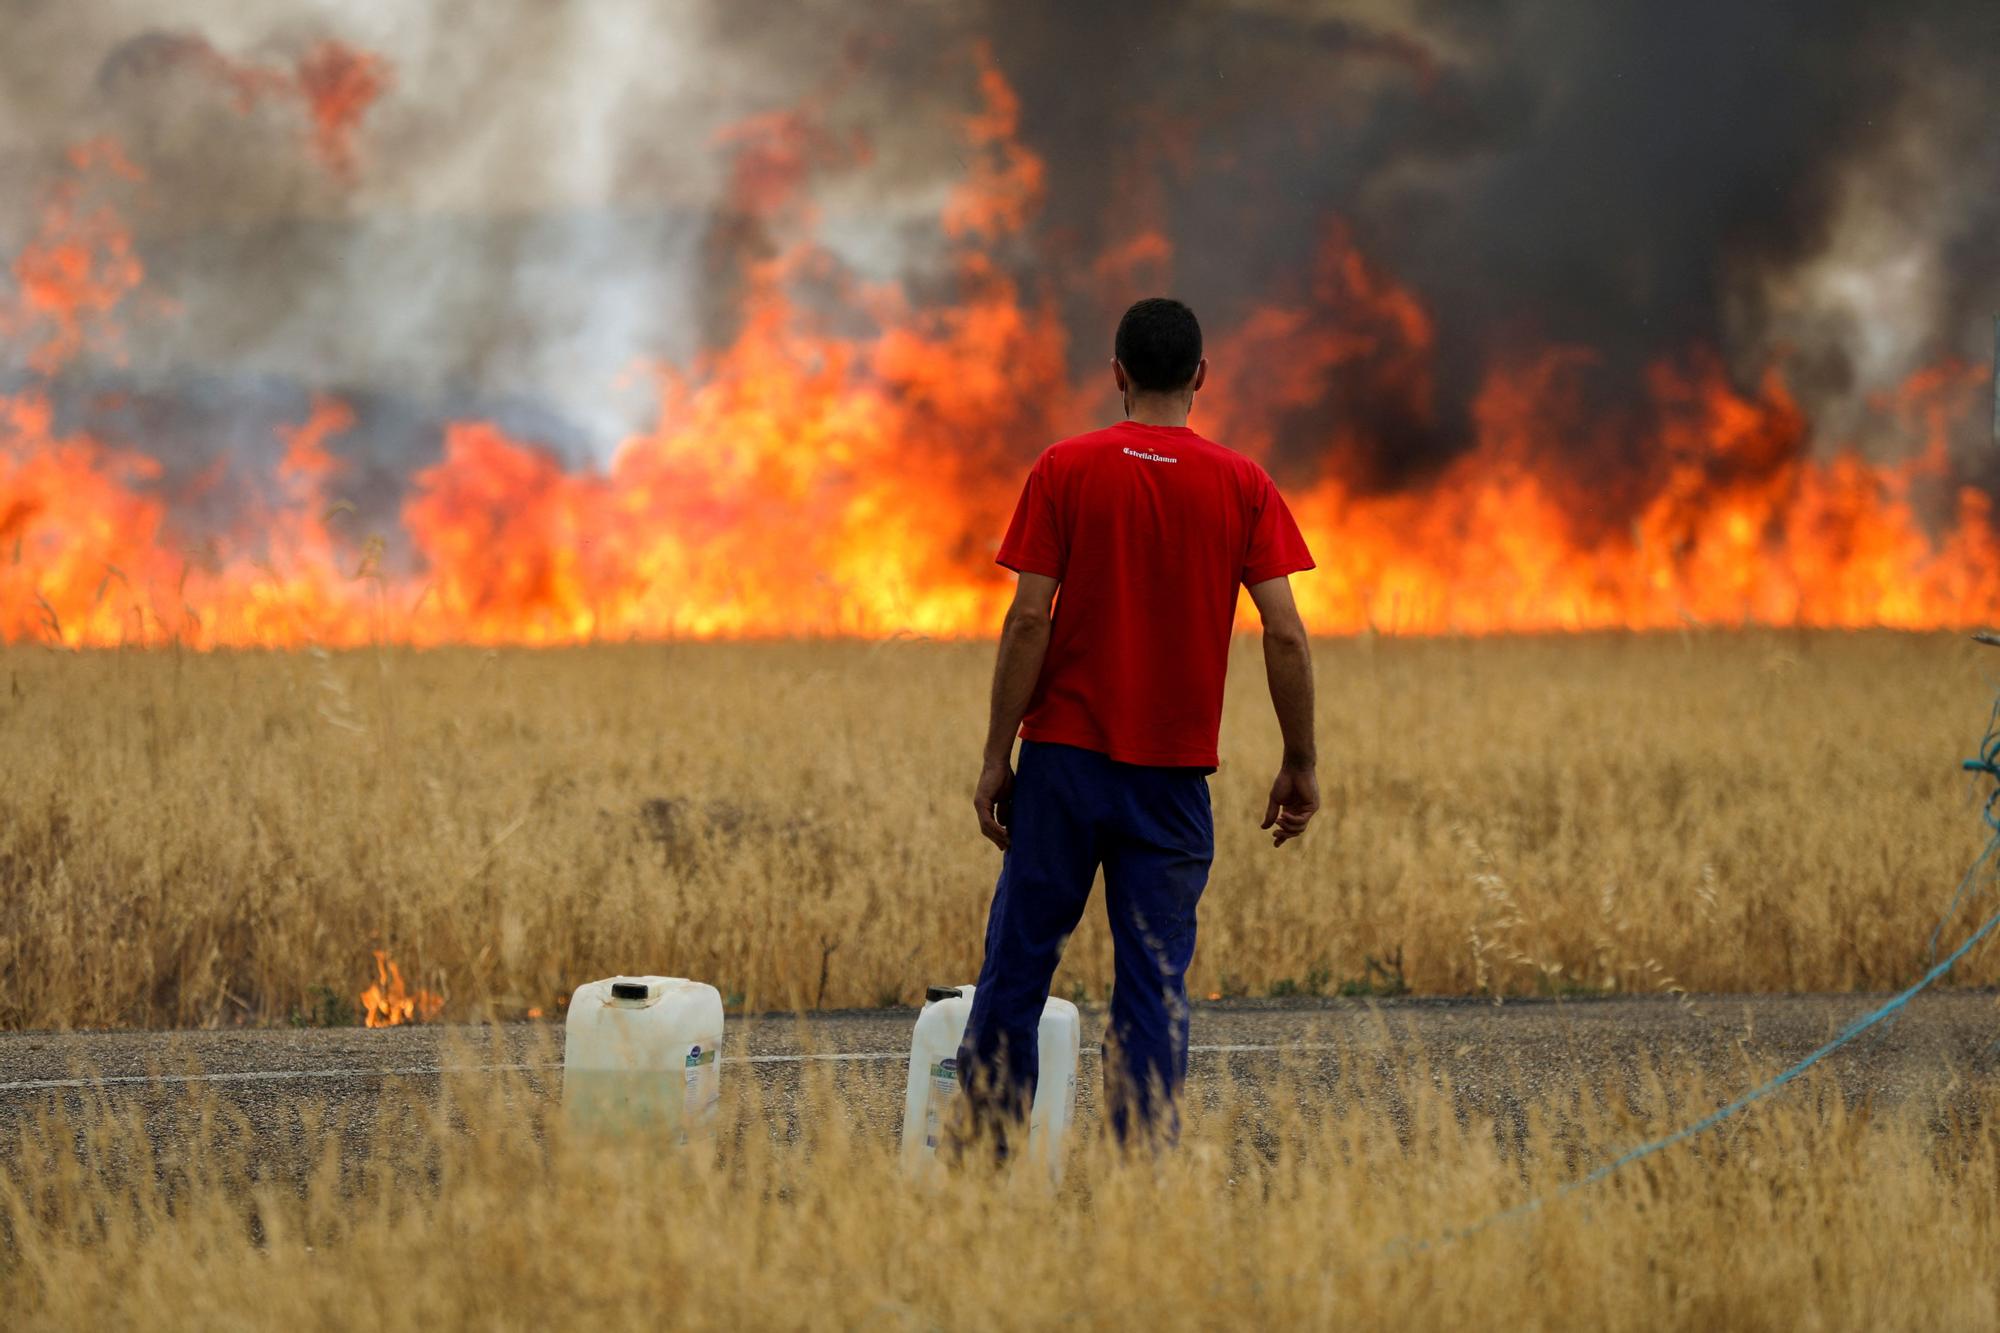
xmin=0 ymin=52 xmax=2000 ymax=646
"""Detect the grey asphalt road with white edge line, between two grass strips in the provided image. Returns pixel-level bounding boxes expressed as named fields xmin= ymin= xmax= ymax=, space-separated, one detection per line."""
xmin=0 ymin=993 xmax=2000 ymax=1147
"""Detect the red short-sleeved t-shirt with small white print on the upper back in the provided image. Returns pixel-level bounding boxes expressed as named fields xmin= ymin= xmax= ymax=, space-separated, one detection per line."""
xmin=998 ymin=420 xmax=1312 ymax=769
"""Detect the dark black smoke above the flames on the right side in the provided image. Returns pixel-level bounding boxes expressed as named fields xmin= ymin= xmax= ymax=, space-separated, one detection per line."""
xmin=972 ymin=0 xmax=2000 ymax=486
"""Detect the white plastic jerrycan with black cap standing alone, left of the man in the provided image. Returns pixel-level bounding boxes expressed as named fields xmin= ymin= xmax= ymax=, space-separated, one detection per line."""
xmin=562 ymin=977 xmax=722 ymax=1143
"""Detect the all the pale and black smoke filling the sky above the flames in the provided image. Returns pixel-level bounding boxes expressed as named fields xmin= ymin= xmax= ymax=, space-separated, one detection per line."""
xmin=0 ymin=0 xmax=2000 ymax=524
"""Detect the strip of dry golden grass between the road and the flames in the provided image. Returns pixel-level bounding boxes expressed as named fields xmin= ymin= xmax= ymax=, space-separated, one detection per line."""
xmin=0 ymin=632 xmax=2000 ymax=1029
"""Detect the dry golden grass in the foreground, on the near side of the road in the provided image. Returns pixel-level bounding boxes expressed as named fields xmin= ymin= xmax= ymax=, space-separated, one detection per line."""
xmin=0 ymin=1032 xmax=2000 ymax=1329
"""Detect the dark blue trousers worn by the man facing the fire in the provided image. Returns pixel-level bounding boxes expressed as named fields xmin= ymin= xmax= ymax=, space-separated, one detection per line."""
xmin=958 ymin=741 xmax=1216 ymax=1153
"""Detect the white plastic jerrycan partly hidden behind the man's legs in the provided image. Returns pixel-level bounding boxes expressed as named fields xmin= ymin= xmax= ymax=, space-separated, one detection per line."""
xmin=902 ymin=987 xmax=1082 ymax=1183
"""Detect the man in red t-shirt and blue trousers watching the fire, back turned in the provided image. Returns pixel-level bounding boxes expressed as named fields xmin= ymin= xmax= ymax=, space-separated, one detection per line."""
xmin=958 ymin=298 xmax=1320 ymax=1153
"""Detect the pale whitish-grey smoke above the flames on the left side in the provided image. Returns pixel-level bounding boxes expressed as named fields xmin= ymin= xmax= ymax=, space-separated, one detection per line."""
xmin=0 ymin=0 xmax=970 ymax=456
